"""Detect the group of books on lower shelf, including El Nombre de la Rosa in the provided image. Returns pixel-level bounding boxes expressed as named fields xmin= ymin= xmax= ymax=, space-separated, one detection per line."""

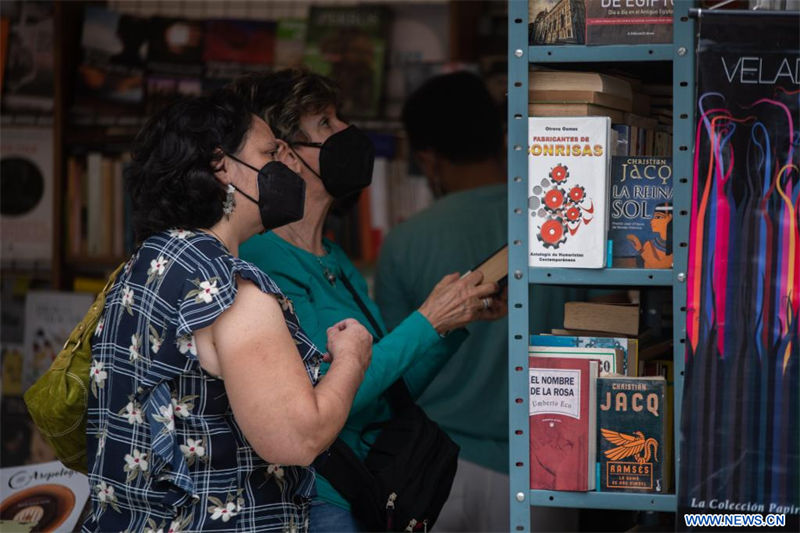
xmin=528 ymin=302 xmax=674 ymax=493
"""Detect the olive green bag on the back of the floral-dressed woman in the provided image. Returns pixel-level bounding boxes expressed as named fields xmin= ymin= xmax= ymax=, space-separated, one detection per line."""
xmin=24 ymin=263 xmax=125 ymax=473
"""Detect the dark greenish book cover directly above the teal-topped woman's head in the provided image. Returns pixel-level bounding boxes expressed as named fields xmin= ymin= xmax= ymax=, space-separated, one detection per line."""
xmin=304 ymin=6 xmax=390 ymax=118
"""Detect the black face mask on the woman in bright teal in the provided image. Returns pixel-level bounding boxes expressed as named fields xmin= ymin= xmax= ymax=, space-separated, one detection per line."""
xmin=292 ymin=126 xmax=375 ymax=200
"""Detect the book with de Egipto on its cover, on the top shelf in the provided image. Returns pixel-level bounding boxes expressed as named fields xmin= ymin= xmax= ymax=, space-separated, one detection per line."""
xmin=586 ymin=0 xmax=673 ymax=45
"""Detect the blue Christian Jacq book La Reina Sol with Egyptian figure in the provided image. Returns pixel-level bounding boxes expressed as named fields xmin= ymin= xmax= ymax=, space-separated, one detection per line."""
xmin=608 ymin=157 xmax=673 ymax=268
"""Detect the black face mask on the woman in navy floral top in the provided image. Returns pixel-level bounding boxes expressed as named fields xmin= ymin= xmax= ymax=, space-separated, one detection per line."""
xmin=228 ymin=154 xmax=306 ymax=231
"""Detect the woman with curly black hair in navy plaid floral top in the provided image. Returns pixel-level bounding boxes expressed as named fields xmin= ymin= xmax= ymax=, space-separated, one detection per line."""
xmin=83 ymin=92 xmax=372 ymax=531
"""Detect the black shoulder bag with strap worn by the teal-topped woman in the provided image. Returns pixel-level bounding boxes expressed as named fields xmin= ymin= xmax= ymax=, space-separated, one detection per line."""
xmin=315 ymin=276 xmax=459 ymax=531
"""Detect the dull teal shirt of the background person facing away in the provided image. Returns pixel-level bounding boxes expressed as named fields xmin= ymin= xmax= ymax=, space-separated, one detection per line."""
xmin=375 ymin=184 xmax=584 ymax=472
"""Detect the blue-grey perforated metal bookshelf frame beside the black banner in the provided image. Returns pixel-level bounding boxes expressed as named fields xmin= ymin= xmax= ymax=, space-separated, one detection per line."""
xmin=508 ymin=0 xmax=694 ymax=531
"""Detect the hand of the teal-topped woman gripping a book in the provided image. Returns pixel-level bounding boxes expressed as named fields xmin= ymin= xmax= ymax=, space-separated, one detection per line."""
xmin=419 ymin=271 xmax=507 ymax=334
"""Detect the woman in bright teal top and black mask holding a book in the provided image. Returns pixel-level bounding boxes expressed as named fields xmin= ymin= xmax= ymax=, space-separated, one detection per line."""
xmin=234 ymin=70 xmax=505 ymax=531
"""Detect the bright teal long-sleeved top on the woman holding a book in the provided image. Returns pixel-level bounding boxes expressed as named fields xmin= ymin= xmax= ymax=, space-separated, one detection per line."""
xmin=240 ymin=232 xmax=467 ymax=509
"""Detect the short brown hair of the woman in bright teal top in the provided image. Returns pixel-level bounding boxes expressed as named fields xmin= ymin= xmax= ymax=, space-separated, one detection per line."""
xmin=229 ymin=69 xmax=341 ymax=143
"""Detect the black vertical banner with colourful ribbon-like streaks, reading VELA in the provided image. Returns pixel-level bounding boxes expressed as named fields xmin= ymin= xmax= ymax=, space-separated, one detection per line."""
xmin=678 ymin=11 xmax=800 ymax=523
